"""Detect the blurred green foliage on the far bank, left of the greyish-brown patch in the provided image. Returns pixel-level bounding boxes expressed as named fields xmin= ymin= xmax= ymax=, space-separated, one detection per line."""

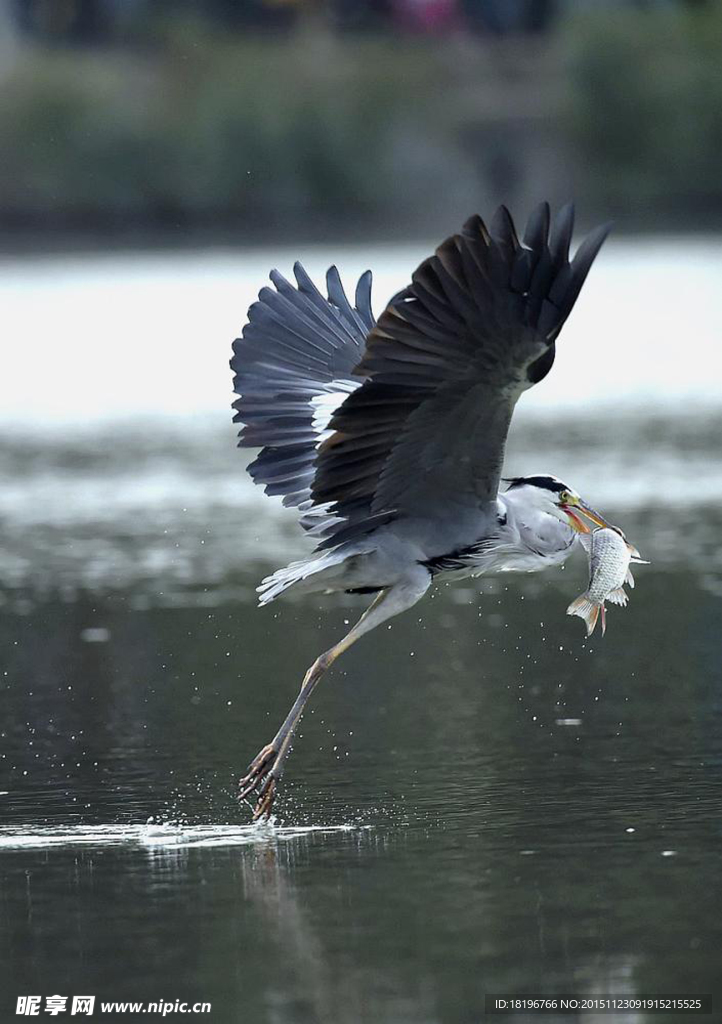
xmin=0 ymin=28 xmax=458 ymax=233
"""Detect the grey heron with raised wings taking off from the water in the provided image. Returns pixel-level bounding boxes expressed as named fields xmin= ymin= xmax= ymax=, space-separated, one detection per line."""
xmin=230 ymin=203 xmax=609 ymax=819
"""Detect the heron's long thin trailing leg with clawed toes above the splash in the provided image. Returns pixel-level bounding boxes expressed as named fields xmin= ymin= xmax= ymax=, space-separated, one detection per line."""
xmin=239 ymin=566 xmax=431 ymax=821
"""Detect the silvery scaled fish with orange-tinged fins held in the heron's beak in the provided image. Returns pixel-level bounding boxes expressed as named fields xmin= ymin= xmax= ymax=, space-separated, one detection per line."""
xmin=566 ymin=528 xmax=642 ymax=637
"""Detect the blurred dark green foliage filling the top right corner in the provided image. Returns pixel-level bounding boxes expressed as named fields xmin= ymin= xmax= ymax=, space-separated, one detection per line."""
xmin=568 ymin=3 xmax=722 ymax=226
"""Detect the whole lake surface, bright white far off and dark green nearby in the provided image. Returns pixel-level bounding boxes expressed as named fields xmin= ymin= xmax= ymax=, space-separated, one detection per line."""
xmin=0 ymin=240 xmax=722 ymax=1024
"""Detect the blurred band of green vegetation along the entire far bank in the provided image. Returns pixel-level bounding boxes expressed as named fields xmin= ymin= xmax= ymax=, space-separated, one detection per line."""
xmin=0 ymin=5 xmax=722 ymax=241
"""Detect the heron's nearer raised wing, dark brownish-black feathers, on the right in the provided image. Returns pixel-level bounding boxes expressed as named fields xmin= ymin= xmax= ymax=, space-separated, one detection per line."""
xmin=311 ymin=203 xmax=608 ymax=546
